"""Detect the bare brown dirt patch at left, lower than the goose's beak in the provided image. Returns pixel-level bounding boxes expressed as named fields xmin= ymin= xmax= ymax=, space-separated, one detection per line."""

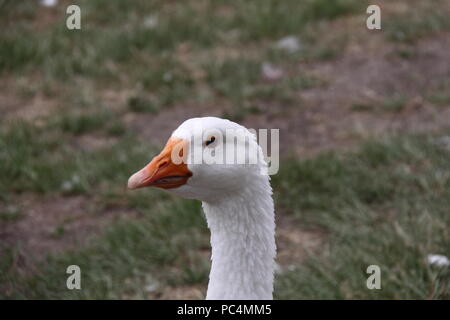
xmin=0 ymin=195 xmax=132 ymax=269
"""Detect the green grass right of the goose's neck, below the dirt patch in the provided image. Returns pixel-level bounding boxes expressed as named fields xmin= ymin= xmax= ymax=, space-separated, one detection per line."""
xmin=275 ymin=136 xmax=450 ymax=299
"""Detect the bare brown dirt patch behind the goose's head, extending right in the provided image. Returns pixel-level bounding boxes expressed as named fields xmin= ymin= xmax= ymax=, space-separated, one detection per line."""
xmin=118 ymin=33 xmax=450 ymax=155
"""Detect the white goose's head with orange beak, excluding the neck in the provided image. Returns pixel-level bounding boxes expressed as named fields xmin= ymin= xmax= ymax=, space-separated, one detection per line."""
xmin=128 ymin=117 xmax=265 ymax=201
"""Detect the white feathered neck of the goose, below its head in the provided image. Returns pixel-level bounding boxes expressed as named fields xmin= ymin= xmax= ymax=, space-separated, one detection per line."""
xmin=203 ymin=175 xmax=276 ymax=299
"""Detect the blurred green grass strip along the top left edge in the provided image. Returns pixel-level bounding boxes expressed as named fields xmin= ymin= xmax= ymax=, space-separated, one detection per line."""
xmin=0 ymin=0 xmax=361 ymax=73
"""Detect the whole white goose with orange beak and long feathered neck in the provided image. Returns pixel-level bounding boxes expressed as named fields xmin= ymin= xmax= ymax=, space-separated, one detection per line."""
xmin=128 ymin=117 xmax=276 ymax=299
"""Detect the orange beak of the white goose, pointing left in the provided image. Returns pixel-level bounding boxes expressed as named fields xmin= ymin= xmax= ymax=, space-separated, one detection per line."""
xmin=128 ymin=138 xmax=192 ymax=189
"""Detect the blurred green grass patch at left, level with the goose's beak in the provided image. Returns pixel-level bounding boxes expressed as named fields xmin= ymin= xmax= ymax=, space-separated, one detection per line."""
xmin=0 ymin=118 xmax=144 ymax=198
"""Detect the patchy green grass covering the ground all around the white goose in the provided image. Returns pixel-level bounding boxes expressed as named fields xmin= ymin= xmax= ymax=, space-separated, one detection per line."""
xmin=0 ymin=0 xmax=450 ymax=299
